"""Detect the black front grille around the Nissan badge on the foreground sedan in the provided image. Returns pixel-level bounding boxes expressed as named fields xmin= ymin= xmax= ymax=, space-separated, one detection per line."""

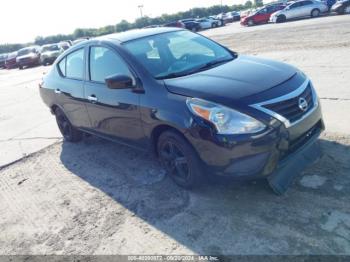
xmin=263 ymin=82 xmax=314 ymax=123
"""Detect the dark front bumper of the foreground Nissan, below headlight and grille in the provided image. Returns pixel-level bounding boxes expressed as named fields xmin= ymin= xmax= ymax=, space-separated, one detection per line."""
xmin=186 ymin=100 xmax=324 ymax=180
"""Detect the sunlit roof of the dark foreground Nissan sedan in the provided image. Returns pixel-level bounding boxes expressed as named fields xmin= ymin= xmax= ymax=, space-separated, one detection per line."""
xmin=95 ymin=27 xmax=183 ymax=43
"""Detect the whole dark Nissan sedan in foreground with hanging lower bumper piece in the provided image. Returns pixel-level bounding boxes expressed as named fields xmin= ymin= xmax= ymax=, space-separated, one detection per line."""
xmin=40 ymin=28 xmax=324 ymax=194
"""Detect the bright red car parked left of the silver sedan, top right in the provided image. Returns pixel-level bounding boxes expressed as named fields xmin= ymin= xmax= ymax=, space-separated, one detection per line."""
xmin=241 ymin=4 xmax=286 ymax=26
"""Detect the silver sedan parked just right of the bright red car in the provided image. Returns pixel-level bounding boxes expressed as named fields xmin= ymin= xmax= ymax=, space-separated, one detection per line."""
xmin=270 ymin=0 xmax=328 ymax=23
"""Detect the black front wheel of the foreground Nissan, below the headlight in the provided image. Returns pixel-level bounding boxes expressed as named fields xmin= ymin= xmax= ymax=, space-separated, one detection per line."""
xmin=157 ymin=131 xmax=204 ymax=189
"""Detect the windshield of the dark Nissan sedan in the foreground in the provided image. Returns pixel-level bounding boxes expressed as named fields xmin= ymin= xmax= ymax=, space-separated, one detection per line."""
xmin=124 ymin=31 xmax=235 ymax=79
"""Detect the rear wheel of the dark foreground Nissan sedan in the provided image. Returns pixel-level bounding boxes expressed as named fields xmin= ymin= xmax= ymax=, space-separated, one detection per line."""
xmin=55 ymin=108 xmax=83 ymax=143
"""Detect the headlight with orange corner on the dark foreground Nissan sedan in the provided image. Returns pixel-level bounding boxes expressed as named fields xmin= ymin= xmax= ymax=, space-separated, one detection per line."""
xmin=186 ymin=98 xmax=266 ymax=135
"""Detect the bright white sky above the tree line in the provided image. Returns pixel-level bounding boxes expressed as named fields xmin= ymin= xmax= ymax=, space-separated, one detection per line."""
xmin=0 ymin=0 xmax=245 ymax=43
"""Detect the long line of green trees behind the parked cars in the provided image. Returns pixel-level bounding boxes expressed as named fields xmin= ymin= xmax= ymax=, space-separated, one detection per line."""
xmin=0 ymin=0 xmax=263 ymax=53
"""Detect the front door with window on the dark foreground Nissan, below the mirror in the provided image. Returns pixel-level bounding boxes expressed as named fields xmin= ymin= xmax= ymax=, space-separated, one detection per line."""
xmin=85 ymin=46 xmax=144 ymax=145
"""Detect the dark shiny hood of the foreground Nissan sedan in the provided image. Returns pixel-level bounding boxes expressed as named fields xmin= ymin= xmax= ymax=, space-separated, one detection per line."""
xmin=164 ymin=56 xmax=297 ymax=104
